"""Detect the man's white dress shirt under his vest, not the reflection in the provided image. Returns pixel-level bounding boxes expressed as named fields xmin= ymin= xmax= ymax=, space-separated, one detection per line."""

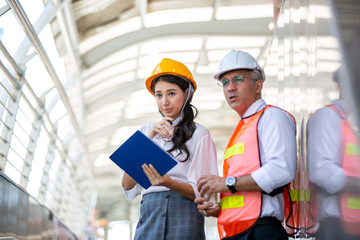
xmin=244 ymin=99 xmax=297 ymax=221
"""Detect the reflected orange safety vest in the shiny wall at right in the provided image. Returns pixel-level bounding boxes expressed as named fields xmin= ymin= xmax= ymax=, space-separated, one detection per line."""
xmin=328 ymin=105 xmax=360 ymax=236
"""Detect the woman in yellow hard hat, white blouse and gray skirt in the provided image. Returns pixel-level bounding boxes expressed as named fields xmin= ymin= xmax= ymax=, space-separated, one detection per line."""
xmin=122 ymin=58 xmax=218 ymax=240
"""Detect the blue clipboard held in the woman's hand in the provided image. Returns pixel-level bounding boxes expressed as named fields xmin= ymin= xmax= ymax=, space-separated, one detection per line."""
xmin=110 ymin=130 xmax=177 ymax=189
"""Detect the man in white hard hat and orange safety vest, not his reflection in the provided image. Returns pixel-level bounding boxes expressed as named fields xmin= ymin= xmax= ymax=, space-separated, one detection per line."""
xmin=195 ymin=50 xmax=296 ymax=240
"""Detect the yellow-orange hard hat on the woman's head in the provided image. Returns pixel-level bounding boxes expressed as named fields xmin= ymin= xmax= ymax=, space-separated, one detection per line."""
xmin=145 ymin=58 xmax=196 ymax=95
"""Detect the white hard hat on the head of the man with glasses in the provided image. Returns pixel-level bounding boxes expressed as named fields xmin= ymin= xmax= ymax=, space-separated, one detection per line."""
xmin=214 ymin=50 xmax=265 ymax=81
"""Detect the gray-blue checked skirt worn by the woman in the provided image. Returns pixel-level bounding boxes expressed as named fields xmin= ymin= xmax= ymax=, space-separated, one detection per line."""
xmin=134 ymin=191 xmax=205 ymax=240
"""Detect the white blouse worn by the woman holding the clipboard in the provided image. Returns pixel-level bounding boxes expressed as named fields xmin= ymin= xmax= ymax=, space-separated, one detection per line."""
xmin=125 ymin=123 xmax=219 ymax=200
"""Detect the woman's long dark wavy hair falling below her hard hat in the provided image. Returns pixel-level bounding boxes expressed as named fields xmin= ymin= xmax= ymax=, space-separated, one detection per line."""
xmin=153 ymin=75 xmax=198 ymax=162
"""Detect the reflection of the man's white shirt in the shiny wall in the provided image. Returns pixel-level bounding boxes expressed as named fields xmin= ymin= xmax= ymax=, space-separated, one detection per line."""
xmin=307 ymin=100 xmax=347 ymax=220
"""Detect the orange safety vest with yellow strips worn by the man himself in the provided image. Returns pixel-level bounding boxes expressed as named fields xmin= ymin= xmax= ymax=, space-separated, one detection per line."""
xmin=218 ymin=105 xmax=294 ymax=239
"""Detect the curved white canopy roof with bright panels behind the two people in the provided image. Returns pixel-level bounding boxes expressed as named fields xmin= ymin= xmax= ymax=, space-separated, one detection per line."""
xmin=64 ymin=0 xmax=274 ymax=219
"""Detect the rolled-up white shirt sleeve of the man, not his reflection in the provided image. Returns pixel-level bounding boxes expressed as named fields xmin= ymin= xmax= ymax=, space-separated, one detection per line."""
xmin=251 ymin=107 xmax=297 ymax=193
